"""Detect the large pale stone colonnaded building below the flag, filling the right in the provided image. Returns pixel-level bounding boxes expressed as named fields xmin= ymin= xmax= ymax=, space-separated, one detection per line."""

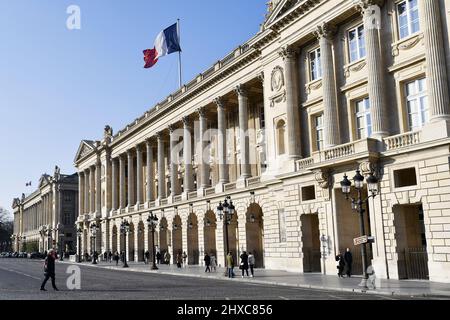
xmin=75 ymin=0 xmax=450 ymax=282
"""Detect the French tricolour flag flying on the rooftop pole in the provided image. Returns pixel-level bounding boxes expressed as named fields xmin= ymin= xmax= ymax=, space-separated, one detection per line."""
xmin=144 ymin=23 xmax=181 ymax=69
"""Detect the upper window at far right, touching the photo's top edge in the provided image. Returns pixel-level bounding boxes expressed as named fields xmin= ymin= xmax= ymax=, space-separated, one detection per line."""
xmin=397 ymin=0 xmax=420 ymax=39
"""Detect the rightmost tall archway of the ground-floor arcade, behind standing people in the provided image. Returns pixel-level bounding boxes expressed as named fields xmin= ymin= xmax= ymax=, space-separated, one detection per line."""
xmin=245 ymin=203 xmax=264 ymax=268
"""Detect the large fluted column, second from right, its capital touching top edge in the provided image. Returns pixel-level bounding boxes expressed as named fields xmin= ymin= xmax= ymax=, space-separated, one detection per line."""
xmin=359 ymin=0 xmax=389 ymax=140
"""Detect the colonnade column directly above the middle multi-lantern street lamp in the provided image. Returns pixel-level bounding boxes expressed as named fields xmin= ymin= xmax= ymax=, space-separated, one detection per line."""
xmin=214 ymin=98 xmax=230 ymax=184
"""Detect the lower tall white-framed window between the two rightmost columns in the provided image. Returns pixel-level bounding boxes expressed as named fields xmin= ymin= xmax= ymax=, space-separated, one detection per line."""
xmin=405 ymin=78 xmax=429 ymax=131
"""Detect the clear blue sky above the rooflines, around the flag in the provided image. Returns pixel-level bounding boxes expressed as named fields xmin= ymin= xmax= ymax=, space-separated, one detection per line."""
xmin=0 ymin=0 xmax=267 ymax=216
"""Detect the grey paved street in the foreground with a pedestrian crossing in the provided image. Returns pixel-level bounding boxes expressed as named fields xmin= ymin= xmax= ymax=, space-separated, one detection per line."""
xmin=0 ymin=259 xmax=436 ymax=300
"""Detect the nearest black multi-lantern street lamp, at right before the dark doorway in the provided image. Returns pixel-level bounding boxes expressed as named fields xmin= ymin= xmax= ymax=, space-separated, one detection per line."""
xmin=341 ymin=170 xmax=378 ymax=288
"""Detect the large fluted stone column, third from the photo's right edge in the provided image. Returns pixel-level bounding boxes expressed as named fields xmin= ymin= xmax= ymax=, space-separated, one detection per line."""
xmin=316 ymin=23 xmax=341 ymax=148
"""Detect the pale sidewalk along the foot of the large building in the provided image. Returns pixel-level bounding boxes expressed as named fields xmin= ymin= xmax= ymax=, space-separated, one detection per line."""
xmin=64 ymin=260 xmax=450 ymax=299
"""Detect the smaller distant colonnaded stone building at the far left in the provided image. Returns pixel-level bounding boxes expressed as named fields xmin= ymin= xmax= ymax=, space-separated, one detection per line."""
xmin=12 ymin=166 xmax=78 ymax=252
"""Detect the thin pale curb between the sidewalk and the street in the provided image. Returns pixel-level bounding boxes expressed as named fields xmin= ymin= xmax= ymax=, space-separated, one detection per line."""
xmin=60 ymin=261 xmax=450 ymax=299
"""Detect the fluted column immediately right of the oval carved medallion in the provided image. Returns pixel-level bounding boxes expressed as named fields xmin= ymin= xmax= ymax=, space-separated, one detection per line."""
xmin=280 ymin=47 xmax=301 ymax=160
